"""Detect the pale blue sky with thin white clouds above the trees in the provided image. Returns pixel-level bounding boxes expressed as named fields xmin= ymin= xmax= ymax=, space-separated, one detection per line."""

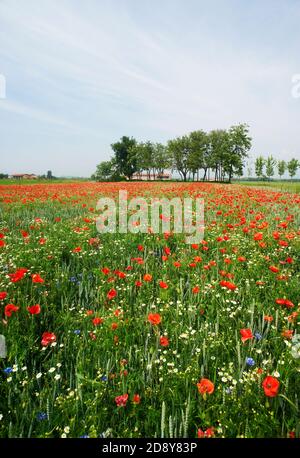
xmin=0 ymin=0 xmax=300 ymax=176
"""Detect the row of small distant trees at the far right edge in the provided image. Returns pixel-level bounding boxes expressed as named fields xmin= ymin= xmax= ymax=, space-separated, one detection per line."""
xmin=255 ymin=156 xmax=300 ymax=180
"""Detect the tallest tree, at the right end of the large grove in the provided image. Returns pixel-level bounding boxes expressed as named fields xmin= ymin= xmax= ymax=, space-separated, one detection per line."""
xmin=223 ymin=124 xmax=252 ymax=183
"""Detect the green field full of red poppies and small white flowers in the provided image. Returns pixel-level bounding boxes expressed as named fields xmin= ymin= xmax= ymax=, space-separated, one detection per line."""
xmin=0 ymin=182 xmax=300 ymax=438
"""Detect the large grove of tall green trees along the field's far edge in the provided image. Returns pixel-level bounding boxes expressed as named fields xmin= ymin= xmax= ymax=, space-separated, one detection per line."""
xmin=92 ymin=124 xmax=252 ymax=182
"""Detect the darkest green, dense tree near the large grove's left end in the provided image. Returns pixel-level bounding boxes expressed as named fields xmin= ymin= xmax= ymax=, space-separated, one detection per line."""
xmin=111 ymin=136 xmax=137 ymax=180
